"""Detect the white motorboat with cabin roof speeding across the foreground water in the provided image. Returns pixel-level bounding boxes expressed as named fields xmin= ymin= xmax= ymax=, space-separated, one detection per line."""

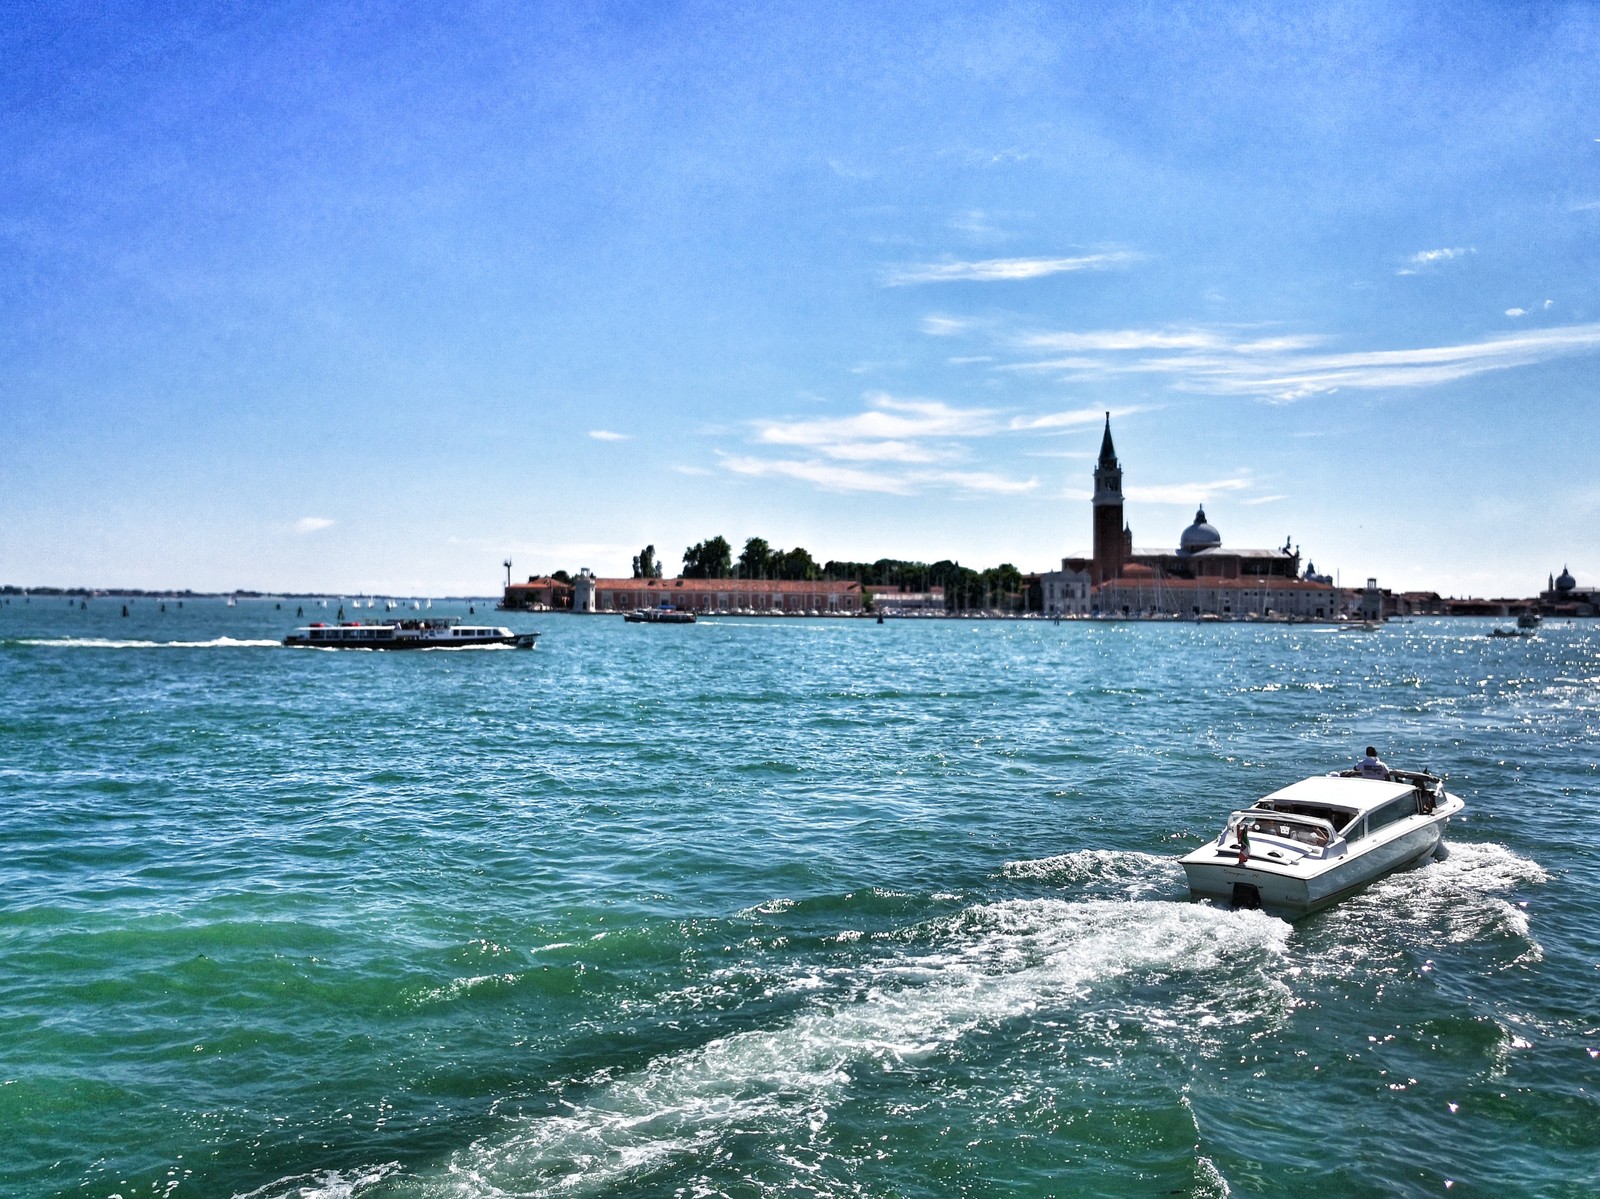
xmin=1181 ymin=770 xmax=1466 ymax=917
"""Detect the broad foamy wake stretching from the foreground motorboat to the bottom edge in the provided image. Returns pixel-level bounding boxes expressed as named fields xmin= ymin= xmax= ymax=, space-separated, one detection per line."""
xmin=278 ymin=900 xmax=1293 ymax=1199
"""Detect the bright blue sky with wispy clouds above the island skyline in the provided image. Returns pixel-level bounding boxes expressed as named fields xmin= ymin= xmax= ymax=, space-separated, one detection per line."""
xmin=0 ymin=0 xmax=1600 ymax=595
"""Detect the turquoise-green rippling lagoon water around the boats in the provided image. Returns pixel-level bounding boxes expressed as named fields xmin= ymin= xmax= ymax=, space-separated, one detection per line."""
xmin=0 ymin=597 xmax=1600 ymax=1199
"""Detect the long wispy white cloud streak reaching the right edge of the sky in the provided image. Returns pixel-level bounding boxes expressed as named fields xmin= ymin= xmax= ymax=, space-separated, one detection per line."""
xmin=1005 ymin=323 xmax=1600 ymax=403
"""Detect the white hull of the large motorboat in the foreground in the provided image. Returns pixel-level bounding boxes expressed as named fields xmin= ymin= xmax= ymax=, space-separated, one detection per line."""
xmin=1182 ymin=796 xmax=1462 ymax=919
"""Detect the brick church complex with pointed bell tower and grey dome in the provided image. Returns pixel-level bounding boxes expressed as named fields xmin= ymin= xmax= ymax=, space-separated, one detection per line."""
xmin=1040 ymin=413 xmax=1339 ymax=620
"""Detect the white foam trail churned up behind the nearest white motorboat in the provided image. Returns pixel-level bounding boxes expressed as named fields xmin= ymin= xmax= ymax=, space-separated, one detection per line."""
xmin=406 ymin=900 xmax=1290 ymax=1197
